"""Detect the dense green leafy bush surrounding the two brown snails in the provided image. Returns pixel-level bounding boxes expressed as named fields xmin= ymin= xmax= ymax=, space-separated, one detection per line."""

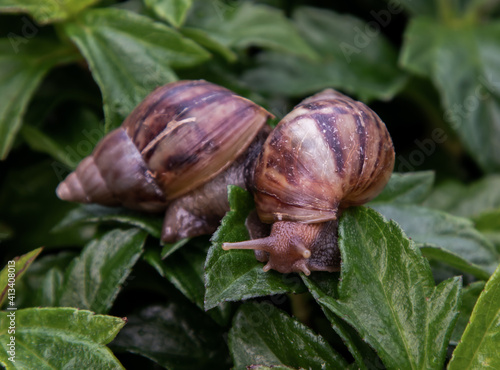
xmin=0 ymin=0 xmax=500 ymax=370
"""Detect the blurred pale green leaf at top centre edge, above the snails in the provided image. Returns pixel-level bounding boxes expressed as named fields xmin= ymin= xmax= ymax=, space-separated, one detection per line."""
xmin=187 ymin=0 xmax=317 ymax=59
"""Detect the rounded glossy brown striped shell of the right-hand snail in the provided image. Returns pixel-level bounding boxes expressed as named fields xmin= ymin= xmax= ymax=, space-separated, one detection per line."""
xmin=253 ymin=89 xmax=394 ymax=223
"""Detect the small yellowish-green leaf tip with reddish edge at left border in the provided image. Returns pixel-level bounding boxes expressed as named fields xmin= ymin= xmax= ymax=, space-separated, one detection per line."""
xmin=0 ymin=248 xmax=42 ymax=307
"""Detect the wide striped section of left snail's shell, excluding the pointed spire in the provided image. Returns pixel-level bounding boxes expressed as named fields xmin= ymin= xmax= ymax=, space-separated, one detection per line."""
xmin=123 ymin=80 xmax=271 ymax=199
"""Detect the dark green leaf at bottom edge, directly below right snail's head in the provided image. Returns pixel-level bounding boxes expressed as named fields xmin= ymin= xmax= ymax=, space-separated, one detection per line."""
xmin=229 ymin=303 xmax=347 ymax=369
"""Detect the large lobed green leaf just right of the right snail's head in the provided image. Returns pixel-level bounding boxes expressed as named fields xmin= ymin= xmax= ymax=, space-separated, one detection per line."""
xmin=303 ymin=207 xmax=461 ymax=369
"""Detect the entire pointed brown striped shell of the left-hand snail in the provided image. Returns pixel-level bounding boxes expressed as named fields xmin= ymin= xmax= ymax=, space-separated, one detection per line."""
xmin=57 ymin=80 xmax=271 ymax=218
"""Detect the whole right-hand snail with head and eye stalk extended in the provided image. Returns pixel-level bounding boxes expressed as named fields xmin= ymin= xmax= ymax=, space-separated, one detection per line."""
xmin=222 ymin=89 xmax=394 ymax=275
